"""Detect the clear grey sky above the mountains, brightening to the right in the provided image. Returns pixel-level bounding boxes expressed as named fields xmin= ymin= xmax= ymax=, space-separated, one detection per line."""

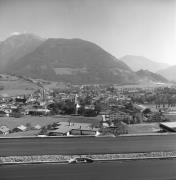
xmin=0 ymin=0 xmax=176 ymax=65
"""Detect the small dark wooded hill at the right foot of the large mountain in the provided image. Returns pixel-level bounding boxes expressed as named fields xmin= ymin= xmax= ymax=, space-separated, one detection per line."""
xmin=136 ymin=70 xmax=168 ymax=83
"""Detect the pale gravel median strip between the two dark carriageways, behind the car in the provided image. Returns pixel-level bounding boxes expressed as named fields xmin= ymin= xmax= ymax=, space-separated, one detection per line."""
xmin=0 ymin=151 xmax=176 ymax=165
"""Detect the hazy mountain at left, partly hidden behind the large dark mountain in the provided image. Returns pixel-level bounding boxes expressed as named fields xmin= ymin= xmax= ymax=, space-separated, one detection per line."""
xmin=0 ymin=33 xmax=43 ymax=72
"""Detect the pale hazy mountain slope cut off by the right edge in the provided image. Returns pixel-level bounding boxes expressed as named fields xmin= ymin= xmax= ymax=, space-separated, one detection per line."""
xmin=157 ymin=65 xmax=176 ymax=81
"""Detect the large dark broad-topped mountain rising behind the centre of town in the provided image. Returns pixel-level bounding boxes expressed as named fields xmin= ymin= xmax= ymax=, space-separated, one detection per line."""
xmin=6 ymin=38 xmax=138 ymax=84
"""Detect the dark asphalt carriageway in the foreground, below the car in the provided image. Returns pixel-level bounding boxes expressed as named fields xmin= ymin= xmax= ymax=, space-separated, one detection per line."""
xmin=0 ymin=160 xmax=176 ymax=180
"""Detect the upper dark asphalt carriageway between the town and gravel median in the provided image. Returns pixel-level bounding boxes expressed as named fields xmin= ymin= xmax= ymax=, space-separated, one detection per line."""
xmin=0 ymin=135 xmax=176 ymax=156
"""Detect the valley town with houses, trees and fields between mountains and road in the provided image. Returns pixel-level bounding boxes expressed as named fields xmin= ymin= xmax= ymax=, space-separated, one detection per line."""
xmin=0 ymin=76 xmax=176 ymax=137
